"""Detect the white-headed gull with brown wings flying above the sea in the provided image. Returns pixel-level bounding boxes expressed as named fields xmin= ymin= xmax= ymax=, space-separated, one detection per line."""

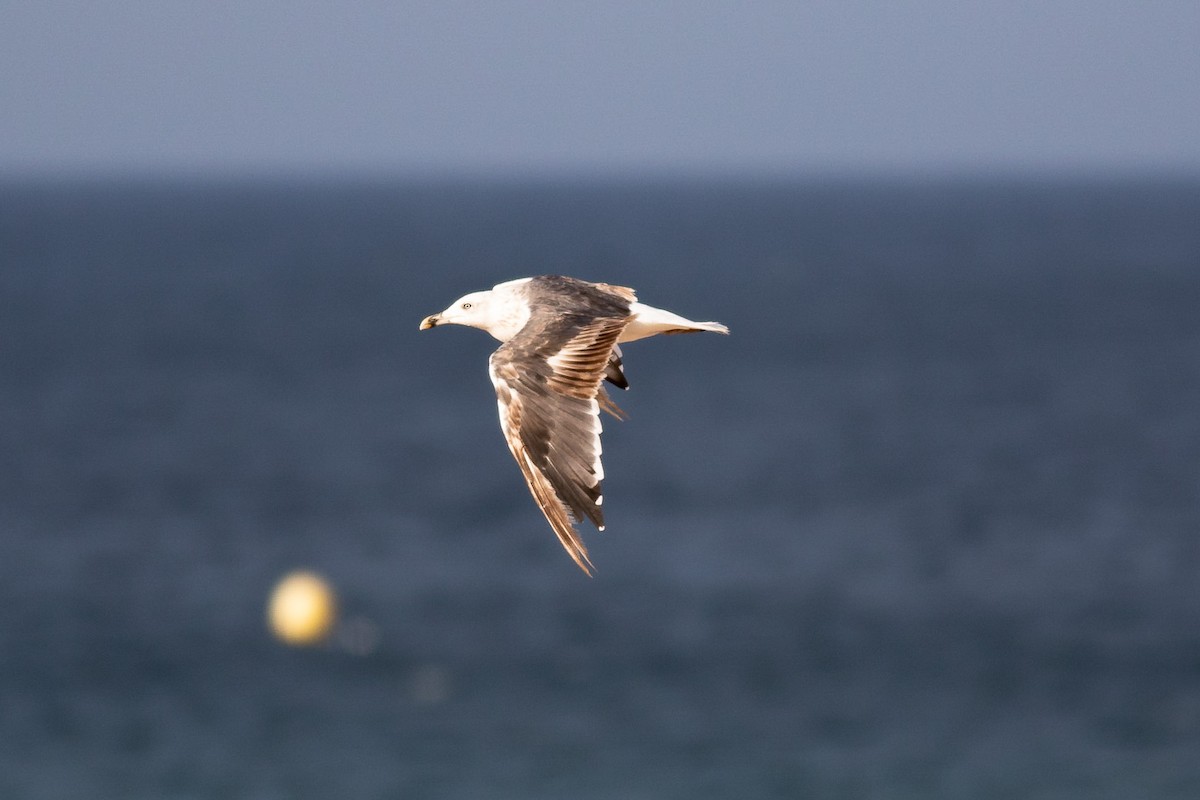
xmin=421 ymin=275 xmax=730 ymax=575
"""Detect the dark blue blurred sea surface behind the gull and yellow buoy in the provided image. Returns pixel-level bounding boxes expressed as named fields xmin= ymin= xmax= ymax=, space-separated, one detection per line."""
xmin=0 ymin=181 xmax=1200 ymax=800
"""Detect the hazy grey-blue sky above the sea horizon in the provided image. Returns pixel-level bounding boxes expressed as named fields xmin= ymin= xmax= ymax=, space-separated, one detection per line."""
xmin=0 ymin=0 xmax=1200 ymax=175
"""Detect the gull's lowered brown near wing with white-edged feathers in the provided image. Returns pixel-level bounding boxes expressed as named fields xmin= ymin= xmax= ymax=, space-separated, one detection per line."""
xmin=488 ymin=311 xmax=629 ymax=575
